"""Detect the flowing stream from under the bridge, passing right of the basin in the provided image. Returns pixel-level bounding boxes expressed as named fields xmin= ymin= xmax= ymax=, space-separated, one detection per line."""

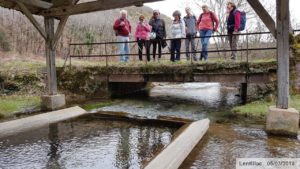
xmin=102 ymin=83 xmax=300 ymax=169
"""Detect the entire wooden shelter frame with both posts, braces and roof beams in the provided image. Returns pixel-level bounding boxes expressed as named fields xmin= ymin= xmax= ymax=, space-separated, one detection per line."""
xmin=0 ymin=0 xmax=290 ymax=109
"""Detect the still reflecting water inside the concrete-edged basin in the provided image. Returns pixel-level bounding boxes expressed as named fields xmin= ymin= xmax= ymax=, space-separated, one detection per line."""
xmin=0 ymin=117 xmax=177 ymax=169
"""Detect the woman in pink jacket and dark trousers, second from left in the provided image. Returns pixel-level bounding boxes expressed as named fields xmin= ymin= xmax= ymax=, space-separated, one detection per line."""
xmin=135 ymin=15 xmax=151 ymax=61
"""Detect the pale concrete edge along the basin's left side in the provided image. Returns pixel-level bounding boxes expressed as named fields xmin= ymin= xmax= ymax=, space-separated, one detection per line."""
xmin=0 ymin=106 xmax=87 ymax=138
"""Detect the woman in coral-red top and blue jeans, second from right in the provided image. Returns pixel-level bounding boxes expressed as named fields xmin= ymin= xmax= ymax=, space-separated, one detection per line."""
xmin=197 ymin=5 xmax=219 ymax=61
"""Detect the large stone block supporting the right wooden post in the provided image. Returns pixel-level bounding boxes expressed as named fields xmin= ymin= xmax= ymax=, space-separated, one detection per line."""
xmin=266 ymin=106 xmax=299 ymax=136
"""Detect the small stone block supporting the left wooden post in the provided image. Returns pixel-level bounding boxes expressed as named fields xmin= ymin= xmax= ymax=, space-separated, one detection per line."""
xmin=41 ymin=94 xmax=66 ymax=110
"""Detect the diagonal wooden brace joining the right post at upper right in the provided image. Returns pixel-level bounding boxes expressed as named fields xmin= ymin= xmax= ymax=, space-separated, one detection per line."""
xmin=247 ymin=0 xmax=276 ymax=38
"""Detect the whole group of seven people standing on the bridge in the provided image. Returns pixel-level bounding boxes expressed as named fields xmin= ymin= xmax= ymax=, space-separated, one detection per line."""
xmin=113 ymin=2 xmax=241 ymax=62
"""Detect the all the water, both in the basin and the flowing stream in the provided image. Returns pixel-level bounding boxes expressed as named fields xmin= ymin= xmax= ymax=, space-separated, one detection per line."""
xmin=0 ymin=83 xmax=300 ymax=169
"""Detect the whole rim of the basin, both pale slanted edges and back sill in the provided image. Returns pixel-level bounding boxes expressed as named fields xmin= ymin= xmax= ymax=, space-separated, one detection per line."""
xmin=0 ymin=106 xmax=210 ymax=169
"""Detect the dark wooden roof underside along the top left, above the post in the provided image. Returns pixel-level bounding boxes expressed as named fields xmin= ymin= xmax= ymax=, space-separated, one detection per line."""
xmin=0 ymin=0 xmax=161 ymax=17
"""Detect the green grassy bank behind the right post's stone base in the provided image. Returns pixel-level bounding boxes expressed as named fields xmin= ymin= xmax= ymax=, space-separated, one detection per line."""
xmin=232 ymin=94 xmax=300 ymax=118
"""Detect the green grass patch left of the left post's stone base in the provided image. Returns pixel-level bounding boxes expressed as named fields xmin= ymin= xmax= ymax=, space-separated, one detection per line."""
xmin=0 ymin=95 xmax=40 ymax=118
